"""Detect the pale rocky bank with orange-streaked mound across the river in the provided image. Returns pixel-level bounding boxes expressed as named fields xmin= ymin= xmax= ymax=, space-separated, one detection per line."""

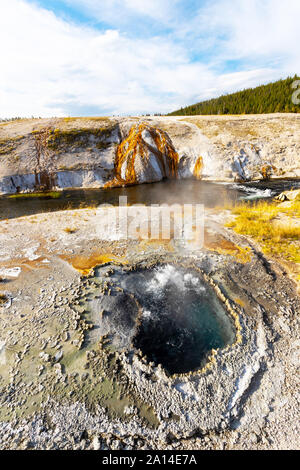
xmin=0 ymin=115 xmax=300 ymax=194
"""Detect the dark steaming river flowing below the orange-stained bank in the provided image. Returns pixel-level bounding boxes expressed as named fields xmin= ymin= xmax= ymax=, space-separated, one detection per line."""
xmin=0 ymin=179 xmax=300 ymax=219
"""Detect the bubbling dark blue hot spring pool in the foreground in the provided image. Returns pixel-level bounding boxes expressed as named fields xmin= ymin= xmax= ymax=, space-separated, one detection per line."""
xmin=105 ymin=264 xmax=235 ymax=374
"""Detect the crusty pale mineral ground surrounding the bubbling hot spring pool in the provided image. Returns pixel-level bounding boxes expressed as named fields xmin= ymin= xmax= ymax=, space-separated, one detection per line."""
xmin=0 ymin=200 xmax=300 ymax=449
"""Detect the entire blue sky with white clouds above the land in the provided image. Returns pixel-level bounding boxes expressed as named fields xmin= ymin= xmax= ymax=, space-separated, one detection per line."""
xmin=0 ymin=0 xmax=300 ymax=117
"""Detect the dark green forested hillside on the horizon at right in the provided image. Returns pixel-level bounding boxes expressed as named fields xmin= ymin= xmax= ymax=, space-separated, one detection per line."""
xmin=168 ymin=75 xmax=300 ymax=116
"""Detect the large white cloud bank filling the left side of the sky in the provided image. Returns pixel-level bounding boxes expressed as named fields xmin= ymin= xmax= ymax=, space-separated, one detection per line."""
xmin=0 ymin=0 xmax=185 ymax=116
